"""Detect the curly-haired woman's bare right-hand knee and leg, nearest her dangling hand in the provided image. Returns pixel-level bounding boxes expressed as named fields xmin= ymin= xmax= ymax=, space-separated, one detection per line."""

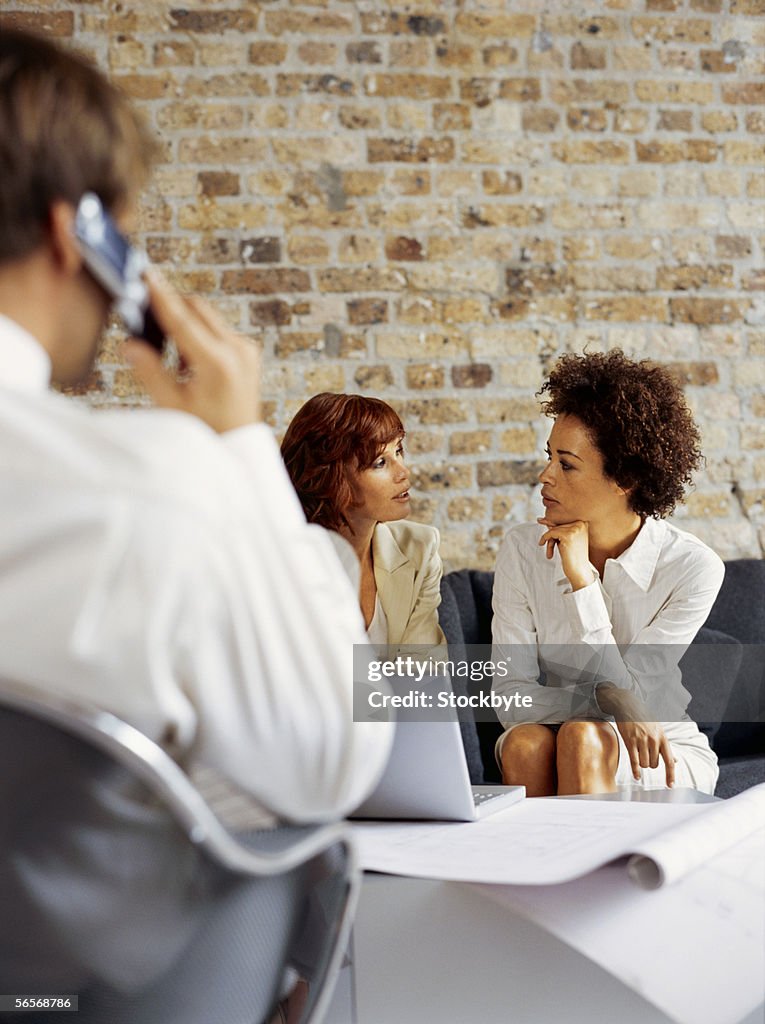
xmin=557 ymin=720 xmax=619 ymax=797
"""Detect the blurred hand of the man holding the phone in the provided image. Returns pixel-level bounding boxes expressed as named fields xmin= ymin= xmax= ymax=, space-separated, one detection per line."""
xmin=123 ymin=270 xmax=260 ymax=433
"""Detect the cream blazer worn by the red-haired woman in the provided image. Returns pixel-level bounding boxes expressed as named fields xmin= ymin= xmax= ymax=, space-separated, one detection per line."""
xmin=372 ymin=519 xmax=447 ymax=646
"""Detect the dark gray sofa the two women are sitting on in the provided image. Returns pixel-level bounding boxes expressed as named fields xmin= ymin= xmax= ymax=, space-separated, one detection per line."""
xmin=439 ymin=558 xmax=765 ymax=797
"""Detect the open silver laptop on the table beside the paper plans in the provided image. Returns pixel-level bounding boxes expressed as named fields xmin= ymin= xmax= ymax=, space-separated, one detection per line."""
xmin=351 ymin=721 xmax=525 ymax=821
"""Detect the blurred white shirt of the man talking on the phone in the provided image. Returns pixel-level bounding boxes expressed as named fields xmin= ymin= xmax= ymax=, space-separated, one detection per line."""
xmin=0 ymin=316 xmax=391 ymax=821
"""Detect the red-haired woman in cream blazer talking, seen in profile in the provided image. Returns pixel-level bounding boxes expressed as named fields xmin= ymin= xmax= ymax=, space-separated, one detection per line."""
xmin=282 ymin=392 xmax=445 ymax=645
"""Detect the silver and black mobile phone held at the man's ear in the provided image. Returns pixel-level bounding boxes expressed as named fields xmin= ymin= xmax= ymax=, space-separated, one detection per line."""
xmin=75 ymin=193 xmax=165 ymax=352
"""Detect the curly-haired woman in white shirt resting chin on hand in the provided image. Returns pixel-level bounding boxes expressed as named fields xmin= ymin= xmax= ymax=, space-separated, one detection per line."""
xmin=493 ymin=349 xmax=724 ymax=796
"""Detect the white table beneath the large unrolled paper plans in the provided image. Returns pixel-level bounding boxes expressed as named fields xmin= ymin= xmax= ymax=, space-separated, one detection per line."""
xmin=327 ymin=791 xmax=764 ymax=1024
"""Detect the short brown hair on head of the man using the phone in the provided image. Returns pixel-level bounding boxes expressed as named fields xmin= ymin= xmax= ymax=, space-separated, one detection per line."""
xmin=0 ymin=30 xmax=154 ymax=265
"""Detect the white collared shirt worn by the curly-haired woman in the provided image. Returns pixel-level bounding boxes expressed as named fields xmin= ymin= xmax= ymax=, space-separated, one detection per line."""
xmin=492 ymin=519 xmax=725 ymax=727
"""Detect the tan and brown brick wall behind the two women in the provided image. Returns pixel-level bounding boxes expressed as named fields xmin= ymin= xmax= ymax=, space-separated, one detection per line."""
xmin=5 ymin=0 xmax=765 ymax=567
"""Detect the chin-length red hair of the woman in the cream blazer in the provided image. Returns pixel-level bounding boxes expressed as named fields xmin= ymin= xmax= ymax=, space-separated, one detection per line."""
xmin=282 ymin=392 xmax=405 ymax=530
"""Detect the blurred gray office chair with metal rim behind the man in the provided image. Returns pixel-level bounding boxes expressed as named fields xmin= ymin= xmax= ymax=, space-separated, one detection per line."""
xmin=0 ymin=682 xmax=359 ymax=1024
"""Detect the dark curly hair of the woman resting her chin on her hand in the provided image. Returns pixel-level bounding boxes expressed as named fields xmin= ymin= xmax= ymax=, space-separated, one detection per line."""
xmin=538 ymin=348 xmax=704 ymax=519
